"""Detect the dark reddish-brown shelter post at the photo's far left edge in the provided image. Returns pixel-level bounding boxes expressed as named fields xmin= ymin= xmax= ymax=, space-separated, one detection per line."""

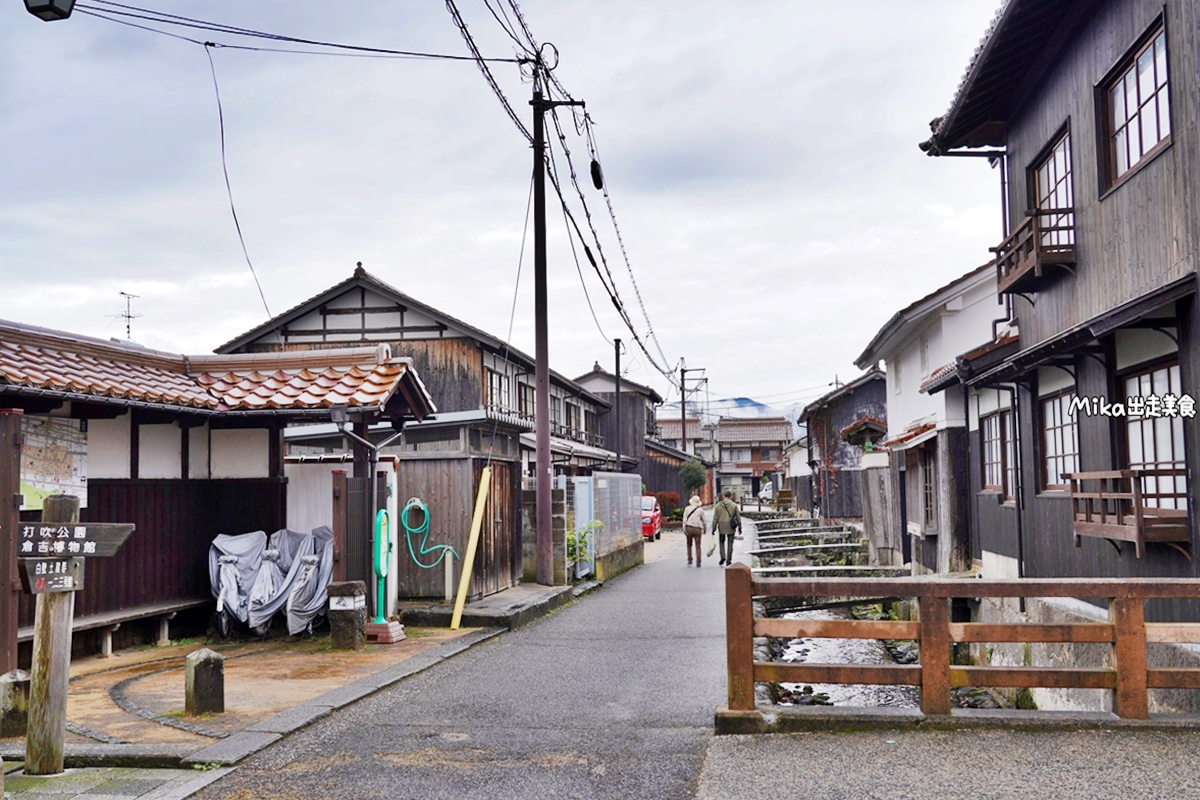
xmin=0 ymin=409 xmax=22 ymax=675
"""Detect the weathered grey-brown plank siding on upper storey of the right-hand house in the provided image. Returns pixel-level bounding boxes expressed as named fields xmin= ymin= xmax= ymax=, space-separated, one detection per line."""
xmin=1007 ymin=0 xmax=1200 ymax=348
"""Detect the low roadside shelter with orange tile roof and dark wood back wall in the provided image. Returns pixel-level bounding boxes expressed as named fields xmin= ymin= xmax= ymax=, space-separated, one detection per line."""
xmin=0 ymin=321 xmax=433 ymax=671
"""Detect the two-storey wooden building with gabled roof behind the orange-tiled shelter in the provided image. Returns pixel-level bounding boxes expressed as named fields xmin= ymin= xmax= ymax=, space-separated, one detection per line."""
xmin=229 ymin=266 xmax=636 ymax=597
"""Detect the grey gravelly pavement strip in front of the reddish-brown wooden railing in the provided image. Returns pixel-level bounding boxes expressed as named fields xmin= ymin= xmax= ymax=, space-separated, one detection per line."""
xmin=697 ymin=730 xmax=1200 ymax=800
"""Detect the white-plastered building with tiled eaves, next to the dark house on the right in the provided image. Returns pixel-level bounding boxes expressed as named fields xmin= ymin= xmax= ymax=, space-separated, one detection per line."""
xmin=854 ymin=263 xmax=1013 ymax=573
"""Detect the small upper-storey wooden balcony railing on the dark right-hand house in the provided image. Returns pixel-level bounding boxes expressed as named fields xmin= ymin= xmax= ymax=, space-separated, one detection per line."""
xmin=991 ymin=209 xmax=1075 ymax=294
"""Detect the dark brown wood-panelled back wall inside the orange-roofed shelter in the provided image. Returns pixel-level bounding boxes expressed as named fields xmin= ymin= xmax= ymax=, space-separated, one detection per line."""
xmin=20 ymin=479 xmax=287 ymax=625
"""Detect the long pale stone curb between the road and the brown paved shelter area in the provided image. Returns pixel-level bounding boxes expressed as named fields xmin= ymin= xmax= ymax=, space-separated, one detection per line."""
xmin=178 ymin=627 xmax=505 ymax=766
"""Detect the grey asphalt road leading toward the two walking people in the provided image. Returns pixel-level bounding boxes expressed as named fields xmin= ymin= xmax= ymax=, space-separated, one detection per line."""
xmin=197 ymin=533 xmax=724 ymax=800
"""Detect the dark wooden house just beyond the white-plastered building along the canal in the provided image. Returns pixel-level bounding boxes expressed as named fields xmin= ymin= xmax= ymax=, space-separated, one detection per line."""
xmin=801 ymin=367 xmax=888 ymax=519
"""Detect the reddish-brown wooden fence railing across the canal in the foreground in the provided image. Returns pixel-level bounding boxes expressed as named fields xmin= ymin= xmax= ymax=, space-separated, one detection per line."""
xmin=725 ymin=565 xmax=1200 ymax=720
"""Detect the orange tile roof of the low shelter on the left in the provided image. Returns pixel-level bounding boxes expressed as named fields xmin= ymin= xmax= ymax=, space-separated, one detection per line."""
xmin=0 ymin=321 xmax=433 ymax=419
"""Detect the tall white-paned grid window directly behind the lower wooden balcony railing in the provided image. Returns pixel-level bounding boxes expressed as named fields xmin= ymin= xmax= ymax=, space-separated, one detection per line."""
xmin=1124 ymin=363 xmax=1188 ymax=509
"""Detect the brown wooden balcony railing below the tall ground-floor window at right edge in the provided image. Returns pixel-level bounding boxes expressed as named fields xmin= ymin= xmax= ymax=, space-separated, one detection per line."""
xmin=1066 ymin=468 xmax=1192 ymax=560
